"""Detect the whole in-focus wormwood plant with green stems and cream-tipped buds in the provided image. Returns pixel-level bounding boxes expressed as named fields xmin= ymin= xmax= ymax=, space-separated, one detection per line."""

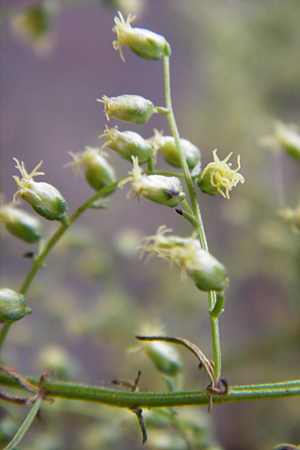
xmin=0 ymin=9 xmax=300 ymax=450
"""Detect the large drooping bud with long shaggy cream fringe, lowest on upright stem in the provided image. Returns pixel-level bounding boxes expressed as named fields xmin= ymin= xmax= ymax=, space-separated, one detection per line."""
xmin=141 ymin=225 xmax=228 ymax=292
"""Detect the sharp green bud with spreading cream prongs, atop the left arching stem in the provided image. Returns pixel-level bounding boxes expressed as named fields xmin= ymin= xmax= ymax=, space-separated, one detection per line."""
xmin=13 ymin=158 xmax=67 ymax=222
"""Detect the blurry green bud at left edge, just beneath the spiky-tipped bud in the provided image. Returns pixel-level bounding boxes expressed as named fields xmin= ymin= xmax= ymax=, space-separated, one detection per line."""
xmin=0 ymin=205 xmax=42 ymax=244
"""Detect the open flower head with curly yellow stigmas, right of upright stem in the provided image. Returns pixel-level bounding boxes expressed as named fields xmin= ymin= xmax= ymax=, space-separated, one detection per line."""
xmin=197 ymin=150 xmax=245 ymax=199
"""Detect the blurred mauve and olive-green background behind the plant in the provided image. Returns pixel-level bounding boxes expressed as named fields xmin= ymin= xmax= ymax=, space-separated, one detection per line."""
xmin=0 ymin=0 xmax=300 ymax=450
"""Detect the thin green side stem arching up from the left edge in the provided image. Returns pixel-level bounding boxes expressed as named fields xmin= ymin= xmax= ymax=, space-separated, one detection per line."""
xmin=0 ymin=178 xmax=123 ymax=350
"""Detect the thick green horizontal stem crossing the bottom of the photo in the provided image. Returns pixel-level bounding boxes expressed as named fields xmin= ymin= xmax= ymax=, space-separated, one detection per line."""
xmin=0 ymin=374 xmax=300 ymax=409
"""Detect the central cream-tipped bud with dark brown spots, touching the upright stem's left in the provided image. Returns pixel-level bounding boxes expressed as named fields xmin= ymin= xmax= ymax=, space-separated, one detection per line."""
xmin=119 ymin=157 xmax=185 ymax=208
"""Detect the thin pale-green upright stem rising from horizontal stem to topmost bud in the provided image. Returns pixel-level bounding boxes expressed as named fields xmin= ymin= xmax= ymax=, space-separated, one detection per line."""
xmin=163 ymin=56 xmax=222 ymax=381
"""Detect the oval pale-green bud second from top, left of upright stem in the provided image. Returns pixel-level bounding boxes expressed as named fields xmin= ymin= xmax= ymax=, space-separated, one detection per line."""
xmin=97 ymin=95 xmax=154 ymax=124
